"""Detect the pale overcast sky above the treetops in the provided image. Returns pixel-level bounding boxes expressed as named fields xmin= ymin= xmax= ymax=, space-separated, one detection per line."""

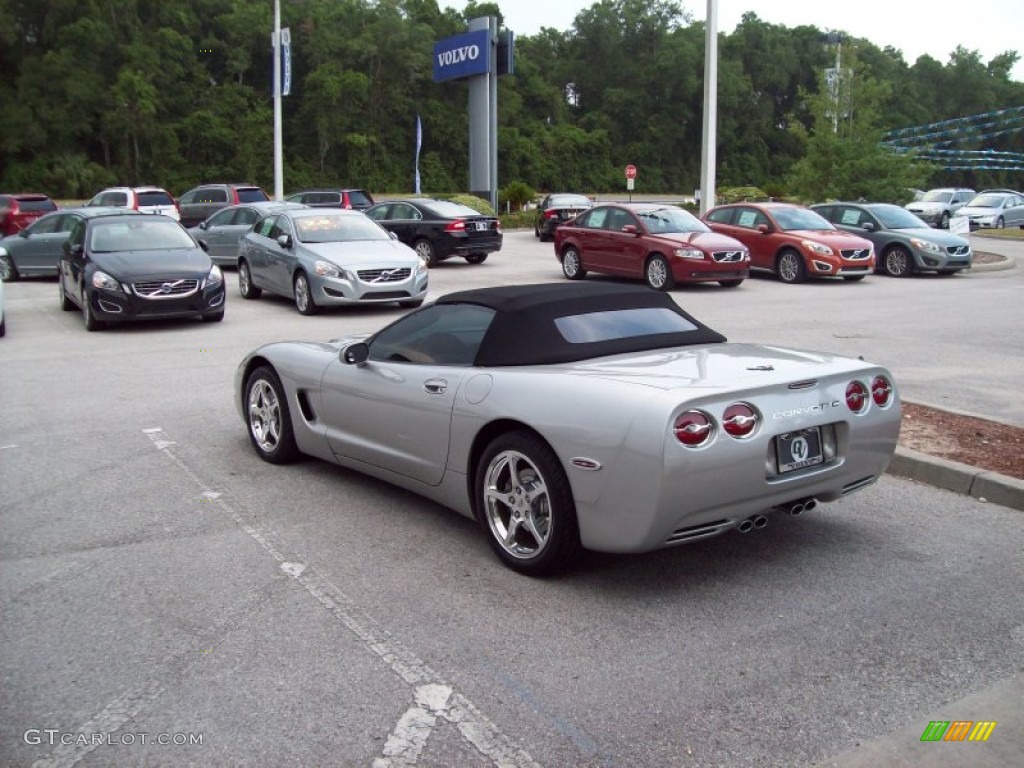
xmin=438 ymin=0 xmax=1024 ymax=81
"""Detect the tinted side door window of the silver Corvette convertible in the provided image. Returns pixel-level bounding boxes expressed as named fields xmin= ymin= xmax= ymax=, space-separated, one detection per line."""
xmin=370 ymin=304 xmax=495 ymax=366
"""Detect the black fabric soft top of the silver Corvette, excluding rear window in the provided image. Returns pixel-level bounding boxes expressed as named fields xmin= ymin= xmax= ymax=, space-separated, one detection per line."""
xmin=435 ymin=282 xmax=726 ymax=367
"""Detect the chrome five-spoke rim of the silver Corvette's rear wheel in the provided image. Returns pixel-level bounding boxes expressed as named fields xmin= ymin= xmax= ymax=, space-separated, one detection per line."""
xmin=483 ymin=451 xmax=551 ymax=560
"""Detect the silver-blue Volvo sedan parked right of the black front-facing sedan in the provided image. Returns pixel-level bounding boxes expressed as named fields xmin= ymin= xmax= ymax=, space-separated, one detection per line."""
xmin=238 ymin=208 xmax=427 ymax=314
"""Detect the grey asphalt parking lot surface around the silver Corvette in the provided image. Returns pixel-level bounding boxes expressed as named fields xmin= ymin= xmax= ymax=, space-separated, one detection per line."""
xmin=0 ymin=231 xmax=1024 ymax=768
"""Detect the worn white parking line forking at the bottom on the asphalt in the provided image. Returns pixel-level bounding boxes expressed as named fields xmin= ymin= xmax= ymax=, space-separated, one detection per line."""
xmin=142 ymin=427 xmax=541 ymax=768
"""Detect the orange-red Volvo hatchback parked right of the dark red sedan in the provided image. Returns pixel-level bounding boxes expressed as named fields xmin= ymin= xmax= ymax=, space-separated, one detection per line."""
xmin=703 ymin=203 xmax=874 ymax=283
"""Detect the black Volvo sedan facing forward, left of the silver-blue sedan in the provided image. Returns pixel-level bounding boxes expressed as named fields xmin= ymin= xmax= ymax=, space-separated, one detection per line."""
xmin=57 ymin=213 xmax=224 ymax=331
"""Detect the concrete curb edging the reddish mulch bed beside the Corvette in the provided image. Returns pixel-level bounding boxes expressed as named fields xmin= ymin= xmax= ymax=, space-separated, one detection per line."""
xmin=886 ymin=445 xmax=1024 ymax=512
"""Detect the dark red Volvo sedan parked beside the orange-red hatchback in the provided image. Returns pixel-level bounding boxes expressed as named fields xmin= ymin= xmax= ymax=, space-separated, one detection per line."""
xmin=555 ymin=203 xmax=750 ymax=291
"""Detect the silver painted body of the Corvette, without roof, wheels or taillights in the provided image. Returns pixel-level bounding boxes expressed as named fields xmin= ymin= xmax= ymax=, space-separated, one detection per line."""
xmin=236 ymin=337 xmax=900 ymax=552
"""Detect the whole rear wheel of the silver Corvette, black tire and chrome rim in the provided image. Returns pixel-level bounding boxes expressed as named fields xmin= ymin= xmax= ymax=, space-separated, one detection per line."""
xmin=473 ymin=430 xmax=583 ymax=577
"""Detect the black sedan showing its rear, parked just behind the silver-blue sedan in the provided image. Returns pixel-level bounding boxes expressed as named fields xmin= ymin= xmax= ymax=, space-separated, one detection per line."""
xmin=366 ymin=198 xmax=502 ymax=266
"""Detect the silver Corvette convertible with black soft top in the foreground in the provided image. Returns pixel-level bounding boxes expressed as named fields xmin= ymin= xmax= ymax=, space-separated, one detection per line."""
xmin=236 ymin=283 xmax=900 ymax=574
